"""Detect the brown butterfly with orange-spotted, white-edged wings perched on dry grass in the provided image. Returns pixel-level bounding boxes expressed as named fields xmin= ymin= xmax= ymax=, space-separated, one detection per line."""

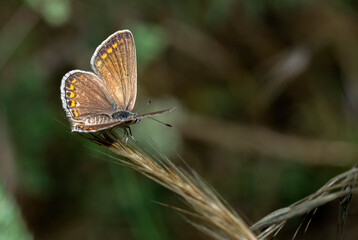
xmin=61 ymin=30 xmax=173 ymax=133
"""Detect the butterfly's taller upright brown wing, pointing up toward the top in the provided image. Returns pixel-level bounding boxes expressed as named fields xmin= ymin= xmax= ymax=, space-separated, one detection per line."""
xmin=91 ymin=30 xmax=137 ymax=111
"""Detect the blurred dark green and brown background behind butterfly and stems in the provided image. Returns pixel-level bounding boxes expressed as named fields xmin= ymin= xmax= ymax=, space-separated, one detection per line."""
xmin=0 ymin=0 xmax=358 ymax=240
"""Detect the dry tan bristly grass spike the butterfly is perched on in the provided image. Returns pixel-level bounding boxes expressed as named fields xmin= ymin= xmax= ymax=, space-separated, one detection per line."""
xmin=90 ymin=132 xmax=257 ymax=239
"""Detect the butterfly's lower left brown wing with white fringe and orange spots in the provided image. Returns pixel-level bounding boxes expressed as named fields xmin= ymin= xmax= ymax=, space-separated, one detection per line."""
xmin=61 ymin=70 xmax=115 ymax=127
